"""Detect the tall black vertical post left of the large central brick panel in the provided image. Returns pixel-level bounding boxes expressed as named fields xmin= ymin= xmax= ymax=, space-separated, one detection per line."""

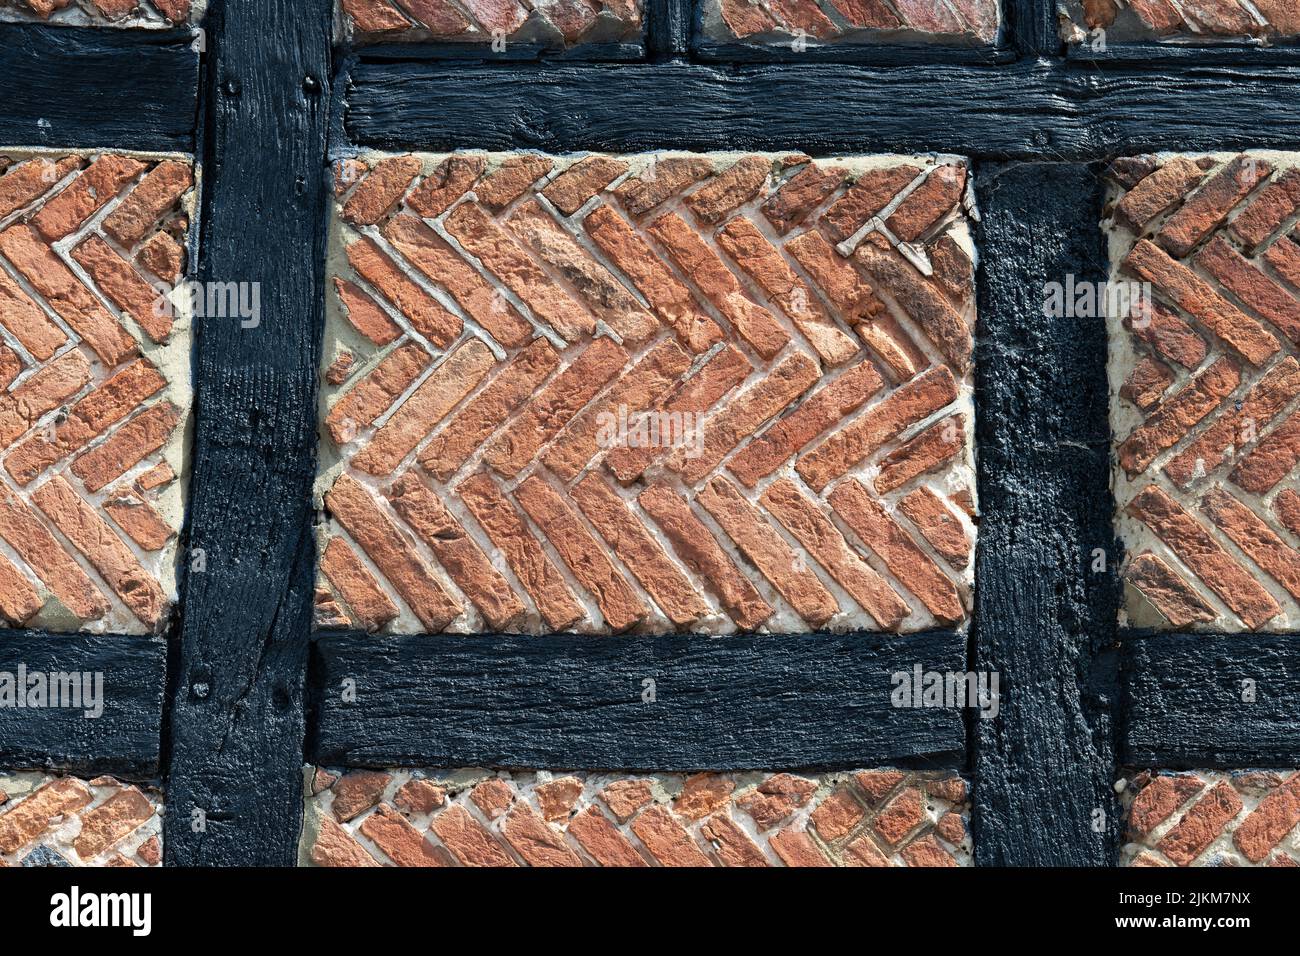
xmin=164 ymin=0 xmax=330 ymax=865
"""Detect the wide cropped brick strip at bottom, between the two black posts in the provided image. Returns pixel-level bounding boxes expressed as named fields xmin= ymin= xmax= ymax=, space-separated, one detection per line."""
xmin=302 ymin=767 xmax=971 ymax=866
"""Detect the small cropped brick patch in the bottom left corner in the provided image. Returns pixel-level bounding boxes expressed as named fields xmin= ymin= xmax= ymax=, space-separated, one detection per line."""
xmin=0 ymin=771 xmax=163 ymax=866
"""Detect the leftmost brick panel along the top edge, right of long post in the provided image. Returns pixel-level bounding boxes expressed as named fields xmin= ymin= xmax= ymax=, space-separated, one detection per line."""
xmin=339 ymin=0 xmax=642 ymax=51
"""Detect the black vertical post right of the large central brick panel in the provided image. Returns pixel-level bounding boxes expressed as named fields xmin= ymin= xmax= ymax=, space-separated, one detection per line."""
xmin=974 ymin=163 xmax=1119 ymax=866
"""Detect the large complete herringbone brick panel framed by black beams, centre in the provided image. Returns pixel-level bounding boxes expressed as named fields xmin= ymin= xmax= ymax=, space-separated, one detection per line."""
xmin=317 ymin=153 xmax=974 ymax=632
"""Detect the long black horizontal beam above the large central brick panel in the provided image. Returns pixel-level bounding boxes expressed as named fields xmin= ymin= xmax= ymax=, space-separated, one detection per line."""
xmin=345 ymin=61 xmax=1300 ymax=161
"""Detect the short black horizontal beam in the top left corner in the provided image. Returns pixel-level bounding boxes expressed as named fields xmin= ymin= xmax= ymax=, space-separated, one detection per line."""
xmin=0 ymin=23 xmax=199 ymax=152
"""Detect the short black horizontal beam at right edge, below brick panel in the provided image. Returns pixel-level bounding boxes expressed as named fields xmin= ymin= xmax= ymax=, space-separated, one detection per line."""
xmin=1121 ymin=633 xmax=1300 ymax=769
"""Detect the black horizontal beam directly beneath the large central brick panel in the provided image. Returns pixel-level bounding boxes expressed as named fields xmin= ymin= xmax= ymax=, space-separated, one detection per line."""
xmin=308 ymin=632 xmax=966 ymax=770
